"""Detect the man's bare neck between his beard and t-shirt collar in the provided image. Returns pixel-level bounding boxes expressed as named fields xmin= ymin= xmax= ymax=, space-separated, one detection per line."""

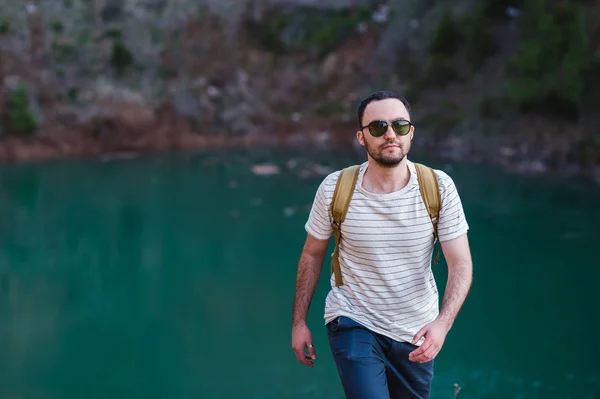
xmin=362 ymin=158 xmax=410 ymax=194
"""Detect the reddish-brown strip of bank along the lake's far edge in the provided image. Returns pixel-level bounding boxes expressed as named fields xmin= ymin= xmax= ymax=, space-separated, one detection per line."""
xmin=0 ymin=127 xmax=600 ymax=185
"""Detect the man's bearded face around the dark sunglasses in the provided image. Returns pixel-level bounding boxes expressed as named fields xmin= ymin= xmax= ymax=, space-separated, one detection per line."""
xmin=356 ymin=98 xmax=414 ymax=168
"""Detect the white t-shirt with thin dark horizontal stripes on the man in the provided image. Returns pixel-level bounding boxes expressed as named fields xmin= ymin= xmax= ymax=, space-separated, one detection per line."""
xmin=305 ymin=160 xmax=469 ymax=345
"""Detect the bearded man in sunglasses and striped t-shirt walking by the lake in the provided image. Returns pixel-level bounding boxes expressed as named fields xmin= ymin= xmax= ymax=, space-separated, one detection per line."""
xmin=292 ymin=91 xmax=472 ymax=399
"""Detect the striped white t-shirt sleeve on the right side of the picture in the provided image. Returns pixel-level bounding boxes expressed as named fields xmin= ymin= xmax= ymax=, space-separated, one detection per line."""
xmin=436 ymin=170 xmax=469 ymax=242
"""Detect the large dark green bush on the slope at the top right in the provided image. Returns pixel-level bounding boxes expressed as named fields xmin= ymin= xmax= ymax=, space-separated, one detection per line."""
xmin=508 ymin=0 xmax=592 ymax=121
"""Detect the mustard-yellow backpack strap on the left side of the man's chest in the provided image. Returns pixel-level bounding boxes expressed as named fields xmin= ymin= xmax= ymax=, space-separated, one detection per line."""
xmin=329 ymin=165 xmax=360 ymax=287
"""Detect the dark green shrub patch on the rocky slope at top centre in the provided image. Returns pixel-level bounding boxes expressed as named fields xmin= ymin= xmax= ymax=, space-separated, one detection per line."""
xmin=249 ymin=7 xmax=372 ymax=56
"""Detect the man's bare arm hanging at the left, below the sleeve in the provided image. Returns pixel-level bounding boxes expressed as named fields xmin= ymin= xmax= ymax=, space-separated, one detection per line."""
xmin=292 ymin=234 xmax=329 ymax=367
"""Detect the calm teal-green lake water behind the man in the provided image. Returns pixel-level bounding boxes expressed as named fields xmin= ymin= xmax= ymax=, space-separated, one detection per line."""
xmin=0 ymin=150 xmax=600 ymax=399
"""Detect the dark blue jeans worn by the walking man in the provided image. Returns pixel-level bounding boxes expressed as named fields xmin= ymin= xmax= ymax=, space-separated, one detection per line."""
xmin=327 ymin=316 xmax=434 ymax=399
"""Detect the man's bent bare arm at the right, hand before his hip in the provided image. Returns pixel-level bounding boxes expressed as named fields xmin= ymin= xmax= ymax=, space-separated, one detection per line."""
xmin=408 ymin=234 xmax=473 ymax=363
